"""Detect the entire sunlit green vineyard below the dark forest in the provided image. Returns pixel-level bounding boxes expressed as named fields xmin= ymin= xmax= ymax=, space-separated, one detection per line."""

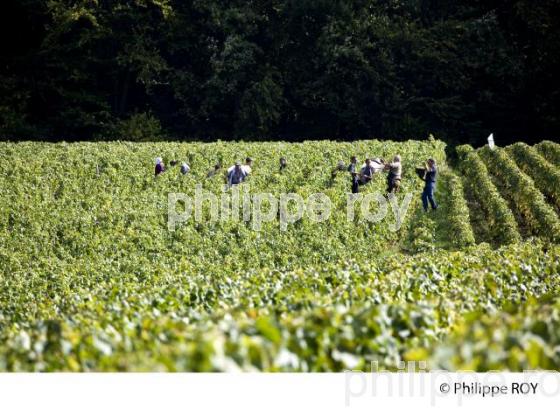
xmin=0 ymin=138 xmax=560 ymax=371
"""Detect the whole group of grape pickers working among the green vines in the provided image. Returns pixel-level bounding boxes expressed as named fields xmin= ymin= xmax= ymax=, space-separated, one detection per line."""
xmin=155 ymin=155 xmax=438 ymax=211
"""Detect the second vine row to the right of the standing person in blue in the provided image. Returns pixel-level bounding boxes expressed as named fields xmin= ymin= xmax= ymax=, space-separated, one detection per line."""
xmin=457 ymin=145 xmax=521 ymax=243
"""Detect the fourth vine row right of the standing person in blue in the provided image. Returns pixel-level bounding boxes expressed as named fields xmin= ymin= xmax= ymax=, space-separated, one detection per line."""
xmin=507 ymin=142 xmax=560 ymax=208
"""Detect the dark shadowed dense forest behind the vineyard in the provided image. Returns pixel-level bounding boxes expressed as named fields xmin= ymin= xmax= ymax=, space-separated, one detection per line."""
xmin=0 ymin=0 xmax=560 ymax=145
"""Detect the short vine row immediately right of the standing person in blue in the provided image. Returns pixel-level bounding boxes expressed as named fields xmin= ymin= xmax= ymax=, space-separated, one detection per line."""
xmin=440 ymin=172 xmax=475 ymax=248
